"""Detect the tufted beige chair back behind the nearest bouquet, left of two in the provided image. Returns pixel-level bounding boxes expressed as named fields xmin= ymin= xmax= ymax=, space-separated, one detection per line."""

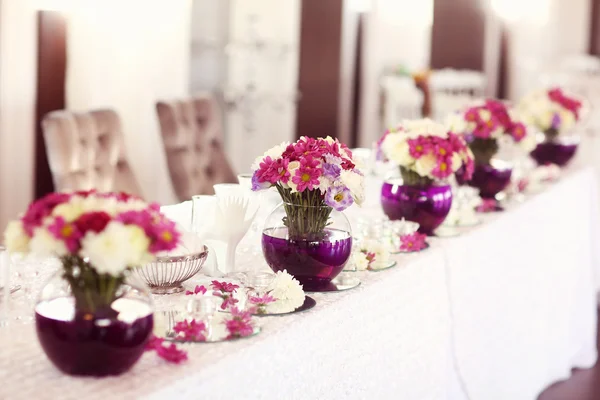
xmin=42 ymin=110 xmax=142 ymax=196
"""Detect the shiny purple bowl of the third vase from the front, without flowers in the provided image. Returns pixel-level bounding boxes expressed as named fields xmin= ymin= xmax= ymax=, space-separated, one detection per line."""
xmin=381 ymin=182 xmax=452 ymax=235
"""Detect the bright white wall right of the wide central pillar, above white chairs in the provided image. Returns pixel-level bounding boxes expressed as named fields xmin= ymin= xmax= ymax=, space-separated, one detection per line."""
xmin=359 ymin=0 xmax=433 ymax=147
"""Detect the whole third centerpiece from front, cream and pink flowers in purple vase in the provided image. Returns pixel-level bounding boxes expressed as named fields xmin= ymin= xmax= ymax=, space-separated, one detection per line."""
xmin=378 ymin=119 xmax=474 ymax=234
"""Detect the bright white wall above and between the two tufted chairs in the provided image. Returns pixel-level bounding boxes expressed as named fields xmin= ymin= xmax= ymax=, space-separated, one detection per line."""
xmin=67 ymin=0 xmax=191 ymax=203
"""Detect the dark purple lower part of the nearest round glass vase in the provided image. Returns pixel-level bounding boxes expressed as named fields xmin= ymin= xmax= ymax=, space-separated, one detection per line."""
xmin=35 ymin=304 xmax=154 ymax=376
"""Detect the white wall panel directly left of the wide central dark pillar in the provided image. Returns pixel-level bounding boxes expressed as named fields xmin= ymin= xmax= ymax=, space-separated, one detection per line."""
xmin=226 ymin=0 xmax=300 ymax=172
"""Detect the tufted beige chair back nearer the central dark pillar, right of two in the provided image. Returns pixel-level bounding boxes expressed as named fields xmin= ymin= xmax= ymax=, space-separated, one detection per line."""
xmin=156 ymin=95 xmax=237 ymax=200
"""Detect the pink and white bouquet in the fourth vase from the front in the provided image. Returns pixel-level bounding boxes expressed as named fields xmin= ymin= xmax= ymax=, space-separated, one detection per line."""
xmin=447 ymin=99 xmax=535 ymax=165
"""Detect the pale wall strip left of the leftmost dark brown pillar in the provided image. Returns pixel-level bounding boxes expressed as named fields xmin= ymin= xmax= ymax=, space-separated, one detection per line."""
xmin=0 ymin=0 xmax=37 ymax=231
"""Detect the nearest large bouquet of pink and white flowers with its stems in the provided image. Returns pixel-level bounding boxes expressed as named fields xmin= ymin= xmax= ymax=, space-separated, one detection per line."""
xmin=5 ymin=191 xmax=180 ymax=313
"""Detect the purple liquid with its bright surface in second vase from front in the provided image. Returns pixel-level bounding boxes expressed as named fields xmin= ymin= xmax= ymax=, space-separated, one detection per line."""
xmin=262 ymin=228 xmax=352 ymax=292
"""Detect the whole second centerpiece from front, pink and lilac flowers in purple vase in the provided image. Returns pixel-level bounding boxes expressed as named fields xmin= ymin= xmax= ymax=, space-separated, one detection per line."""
xmin=252 ymin=137 xmax=364 ymax=288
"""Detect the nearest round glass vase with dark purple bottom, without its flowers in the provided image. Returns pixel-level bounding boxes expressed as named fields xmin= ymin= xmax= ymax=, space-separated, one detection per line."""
xmin=35 ymin=269 xmax=154 ymax=377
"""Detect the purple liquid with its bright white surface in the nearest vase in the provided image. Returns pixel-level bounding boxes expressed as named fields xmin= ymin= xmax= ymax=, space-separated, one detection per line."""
xmin=35 ymin=297 xmax=153 ymax=376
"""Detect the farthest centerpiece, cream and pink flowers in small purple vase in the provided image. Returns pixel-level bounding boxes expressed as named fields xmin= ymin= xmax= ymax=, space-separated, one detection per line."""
xmin=519 ymin=88 xmax=583 ymax=167
